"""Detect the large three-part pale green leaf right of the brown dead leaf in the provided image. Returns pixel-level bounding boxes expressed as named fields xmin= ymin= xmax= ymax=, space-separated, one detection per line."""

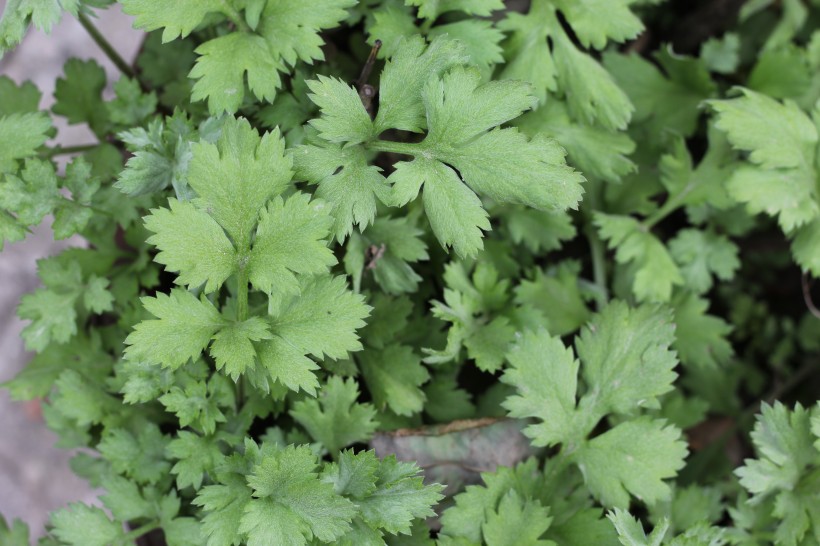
xmin=501 ymin=302 xmax=687 ymax=506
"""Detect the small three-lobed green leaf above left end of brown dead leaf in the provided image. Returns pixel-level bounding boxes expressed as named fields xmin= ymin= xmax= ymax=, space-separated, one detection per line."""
xmin=290 ymin=376 xmax=377 ymax=456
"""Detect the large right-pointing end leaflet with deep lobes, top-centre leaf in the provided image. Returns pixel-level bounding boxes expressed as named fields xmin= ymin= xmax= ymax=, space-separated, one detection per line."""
xmin=388 ymin=68 xmax=583 ymax=256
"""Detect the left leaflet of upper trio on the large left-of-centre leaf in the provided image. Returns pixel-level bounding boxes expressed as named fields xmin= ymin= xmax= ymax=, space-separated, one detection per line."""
xmin=145 ymin=199 xmax=237 ymax=294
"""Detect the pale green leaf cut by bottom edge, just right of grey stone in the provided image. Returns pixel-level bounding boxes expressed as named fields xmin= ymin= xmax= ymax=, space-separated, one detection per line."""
xmin=51 ymin=502 xmax=125 ymax=546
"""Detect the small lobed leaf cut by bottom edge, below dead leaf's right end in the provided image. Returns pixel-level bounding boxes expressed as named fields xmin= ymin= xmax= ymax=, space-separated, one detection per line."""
xmin=482 ymin=490 xmax=555 ymax=546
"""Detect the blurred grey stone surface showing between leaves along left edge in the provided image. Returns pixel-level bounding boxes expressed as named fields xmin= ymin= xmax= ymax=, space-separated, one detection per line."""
xmin=0 ymin=0 xmax=141 ymax=537
